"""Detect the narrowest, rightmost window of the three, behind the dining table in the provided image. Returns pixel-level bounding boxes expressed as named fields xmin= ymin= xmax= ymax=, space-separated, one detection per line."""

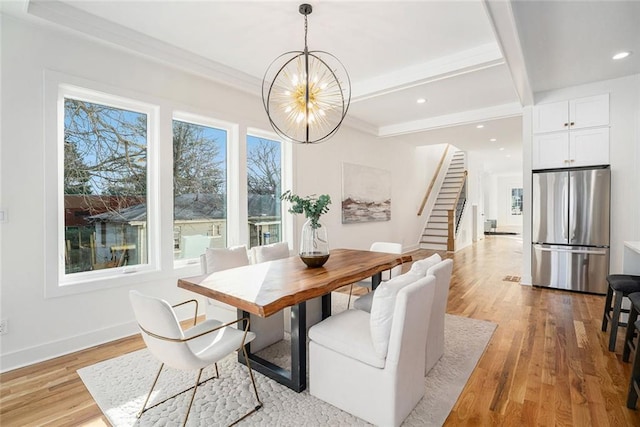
xmin=247 ymin=135 xmax=283 ymax=247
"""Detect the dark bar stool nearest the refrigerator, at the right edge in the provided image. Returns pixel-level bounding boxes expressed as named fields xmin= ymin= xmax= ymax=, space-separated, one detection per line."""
xmin=602 ymin=274 xmax=640 ymax=351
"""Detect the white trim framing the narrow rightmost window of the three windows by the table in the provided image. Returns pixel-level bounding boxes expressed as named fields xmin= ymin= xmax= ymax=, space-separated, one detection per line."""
xmin=244 ymin=128 xmax=296 ymax=251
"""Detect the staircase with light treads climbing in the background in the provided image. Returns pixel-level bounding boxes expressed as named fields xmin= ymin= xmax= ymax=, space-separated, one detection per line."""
xmin=420 ymin=151 xmax=465 ymax=251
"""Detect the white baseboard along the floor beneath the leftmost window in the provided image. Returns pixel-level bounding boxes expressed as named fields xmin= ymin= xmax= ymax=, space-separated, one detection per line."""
xmin=0 ymin=321 xmax=139 ymax=373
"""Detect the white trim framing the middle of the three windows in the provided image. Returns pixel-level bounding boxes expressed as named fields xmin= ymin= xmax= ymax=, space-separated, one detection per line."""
xmin=171 ymin=110 xmax=240 ymax=269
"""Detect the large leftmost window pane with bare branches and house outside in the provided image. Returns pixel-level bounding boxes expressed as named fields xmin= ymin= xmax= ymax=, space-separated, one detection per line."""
xmin=62 ymin=96 xmax=149 ymax=275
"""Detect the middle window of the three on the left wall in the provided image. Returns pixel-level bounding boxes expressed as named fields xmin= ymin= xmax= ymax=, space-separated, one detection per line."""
xmin=173 ymin=115 xmax=228 ymax=260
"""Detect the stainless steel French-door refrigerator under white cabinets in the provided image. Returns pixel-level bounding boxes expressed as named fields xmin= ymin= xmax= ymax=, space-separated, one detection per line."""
xmin=531 ymin=167 xmax=611 ymax=294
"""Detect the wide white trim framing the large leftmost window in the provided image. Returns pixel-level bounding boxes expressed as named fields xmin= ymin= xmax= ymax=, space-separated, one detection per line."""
xmin=43 ymin=70 xmax=160 ymax=298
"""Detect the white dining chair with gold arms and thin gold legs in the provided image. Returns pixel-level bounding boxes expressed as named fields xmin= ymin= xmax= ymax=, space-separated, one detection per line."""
xmin=129 ymin=291 xmax=262 ymax=426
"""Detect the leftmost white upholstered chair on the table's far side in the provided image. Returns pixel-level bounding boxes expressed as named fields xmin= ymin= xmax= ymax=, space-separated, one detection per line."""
xmin=200 ymin=245 xmax=284 ymax=352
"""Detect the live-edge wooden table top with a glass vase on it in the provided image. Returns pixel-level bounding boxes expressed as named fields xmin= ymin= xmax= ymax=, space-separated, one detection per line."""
xmin=178 ymin=249 xmax=412 ymax=317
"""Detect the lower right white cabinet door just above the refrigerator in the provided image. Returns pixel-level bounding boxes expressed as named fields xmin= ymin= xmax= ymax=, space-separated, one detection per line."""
xmin=569 ymin=127 xmax=609 ymax=167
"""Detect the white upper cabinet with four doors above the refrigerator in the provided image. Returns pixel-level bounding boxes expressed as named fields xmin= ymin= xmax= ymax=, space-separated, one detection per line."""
xmin=531 ymin=94 xmax=609 ymax=169
